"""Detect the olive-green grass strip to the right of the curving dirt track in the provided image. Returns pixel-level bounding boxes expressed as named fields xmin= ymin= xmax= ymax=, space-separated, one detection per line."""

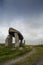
xmin=14 ymin=45 xmax=43 ymax=65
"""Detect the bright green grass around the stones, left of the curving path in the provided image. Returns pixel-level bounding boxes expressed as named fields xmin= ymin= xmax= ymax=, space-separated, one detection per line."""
xmin=0 ymin=46 xmax=32 ymax=63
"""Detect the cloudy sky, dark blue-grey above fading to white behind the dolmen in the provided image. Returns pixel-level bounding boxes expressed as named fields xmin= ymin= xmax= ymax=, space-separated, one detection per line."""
xmin=0 ymin=0 xmax=43 ymax=44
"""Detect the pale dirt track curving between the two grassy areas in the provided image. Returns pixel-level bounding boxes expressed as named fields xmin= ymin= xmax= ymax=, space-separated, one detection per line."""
xmin=0 ymin=48 xmax=36 ymax=65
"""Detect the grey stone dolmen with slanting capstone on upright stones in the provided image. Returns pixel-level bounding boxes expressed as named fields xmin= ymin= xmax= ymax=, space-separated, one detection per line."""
xmin=5 ymin=28 xmax=23 ymax=47
